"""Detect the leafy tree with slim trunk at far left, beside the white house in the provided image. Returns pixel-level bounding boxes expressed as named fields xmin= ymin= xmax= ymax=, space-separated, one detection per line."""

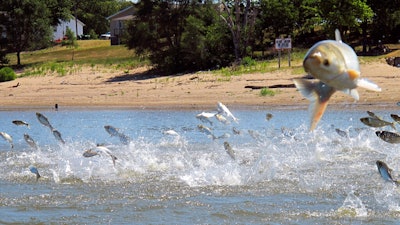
xmin=0 ymin=0 xmax=52 ymax=65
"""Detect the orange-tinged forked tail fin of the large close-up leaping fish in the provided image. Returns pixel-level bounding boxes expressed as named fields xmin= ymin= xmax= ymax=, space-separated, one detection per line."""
xmin=293 ymin=79 xmax=336 ymax=130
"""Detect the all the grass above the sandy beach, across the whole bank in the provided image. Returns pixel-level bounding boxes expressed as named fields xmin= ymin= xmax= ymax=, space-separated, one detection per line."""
xmin=8 ymin=40 xmax=400 ymax=76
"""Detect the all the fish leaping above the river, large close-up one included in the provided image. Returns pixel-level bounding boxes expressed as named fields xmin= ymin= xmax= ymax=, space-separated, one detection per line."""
xmin=0 ymin=30 xmax=400 ymax=185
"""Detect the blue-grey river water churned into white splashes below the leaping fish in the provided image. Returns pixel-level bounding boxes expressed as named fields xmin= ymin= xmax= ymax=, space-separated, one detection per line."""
xmin=0 ymin=109 xmax=400 ymax=224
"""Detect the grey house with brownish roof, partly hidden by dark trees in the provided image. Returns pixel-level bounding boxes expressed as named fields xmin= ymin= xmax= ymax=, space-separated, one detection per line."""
xmin=106 ymin=6 xmax=135 ymax=45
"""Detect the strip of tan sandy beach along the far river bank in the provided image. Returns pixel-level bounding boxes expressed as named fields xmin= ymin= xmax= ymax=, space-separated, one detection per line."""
xmin=0 ymin=60 xmax=400 ymax=110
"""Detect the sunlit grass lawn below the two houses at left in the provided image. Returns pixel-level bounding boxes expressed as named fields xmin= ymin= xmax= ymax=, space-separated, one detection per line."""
xmin=7 ymin=40 xmax=148 ymax=76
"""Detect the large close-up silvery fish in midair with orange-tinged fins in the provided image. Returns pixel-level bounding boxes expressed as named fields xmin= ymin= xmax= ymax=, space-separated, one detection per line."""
xmin=293 ymin=30 xmax=381 ymax=130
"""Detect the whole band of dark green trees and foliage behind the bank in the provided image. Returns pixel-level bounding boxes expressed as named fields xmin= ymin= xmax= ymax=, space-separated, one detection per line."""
xmin=0 ymin=0 xmax=400 ymax=71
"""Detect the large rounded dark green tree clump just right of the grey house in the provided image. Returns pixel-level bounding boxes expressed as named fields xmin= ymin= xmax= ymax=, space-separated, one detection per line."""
xmin=126 ymin=0 xmax=234 ymax=73
